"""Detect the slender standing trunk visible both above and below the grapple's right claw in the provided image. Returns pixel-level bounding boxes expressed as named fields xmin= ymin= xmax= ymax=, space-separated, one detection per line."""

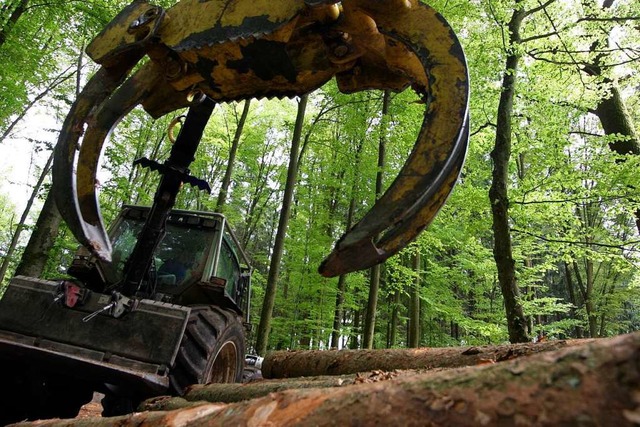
xmin=363 ymin=90 xmax=391 ymax=349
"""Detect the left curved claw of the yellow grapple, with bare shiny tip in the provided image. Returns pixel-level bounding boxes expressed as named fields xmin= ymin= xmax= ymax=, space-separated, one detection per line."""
xmin=53 ymin=67 xmax=159 ymax=261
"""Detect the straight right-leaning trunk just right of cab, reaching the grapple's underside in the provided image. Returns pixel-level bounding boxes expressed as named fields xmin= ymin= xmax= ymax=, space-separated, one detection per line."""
xmin=256 ymin=95 xmax=308 ymax=355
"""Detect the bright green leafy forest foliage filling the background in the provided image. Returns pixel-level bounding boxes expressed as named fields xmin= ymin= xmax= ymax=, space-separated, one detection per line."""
xmin=0 ymin=0 xmax=640 ymax=349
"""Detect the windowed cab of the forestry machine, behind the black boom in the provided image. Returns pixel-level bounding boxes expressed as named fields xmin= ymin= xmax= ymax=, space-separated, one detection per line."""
xmin=69 ymin=205 xmax=251 ymax=313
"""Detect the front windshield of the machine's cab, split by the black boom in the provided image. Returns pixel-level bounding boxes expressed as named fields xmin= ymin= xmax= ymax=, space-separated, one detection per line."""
xmin=112 ymin=218 xmax=215 ymax=287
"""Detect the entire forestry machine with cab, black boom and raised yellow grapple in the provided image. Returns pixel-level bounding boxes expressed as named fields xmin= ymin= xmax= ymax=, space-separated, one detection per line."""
xmin=0 ymin=0 xmax=469 ymax=421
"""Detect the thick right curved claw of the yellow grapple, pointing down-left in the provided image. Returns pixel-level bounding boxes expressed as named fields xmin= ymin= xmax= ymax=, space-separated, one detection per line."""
xmin=319 ymin=0 xmax=469 ymax=277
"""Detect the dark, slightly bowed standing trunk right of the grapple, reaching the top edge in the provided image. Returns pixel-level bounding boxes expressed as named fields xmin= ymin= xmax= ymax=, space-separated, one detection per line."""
xmin=489 ymin=0 xmax=528 ymax=343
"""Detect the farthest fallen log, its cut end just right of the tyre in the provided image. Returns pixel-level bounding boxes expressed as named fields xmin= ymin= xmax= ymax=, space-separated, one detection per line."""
xmin=262 ymin=340 xmax=588 ymax=378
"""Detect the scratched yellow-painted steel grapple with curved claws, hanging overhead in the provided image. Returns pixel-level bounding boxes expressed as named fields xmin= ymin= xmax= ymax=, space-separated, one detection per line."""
xmin=56 ymin=0 xmax=469 ymax=275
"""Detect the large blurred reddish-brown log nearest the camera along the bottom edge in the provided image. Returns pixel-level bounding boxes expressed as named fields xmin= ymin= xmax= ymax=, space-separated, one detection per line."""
xmin=22 ymin=333 xmax=640 ymax=427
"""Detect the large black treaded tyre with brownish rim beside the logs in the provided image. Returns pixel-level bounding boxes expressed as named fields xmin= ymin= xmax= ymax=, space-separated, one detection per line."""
xmin=169 ymin=306 xmax=244 ymax=395
